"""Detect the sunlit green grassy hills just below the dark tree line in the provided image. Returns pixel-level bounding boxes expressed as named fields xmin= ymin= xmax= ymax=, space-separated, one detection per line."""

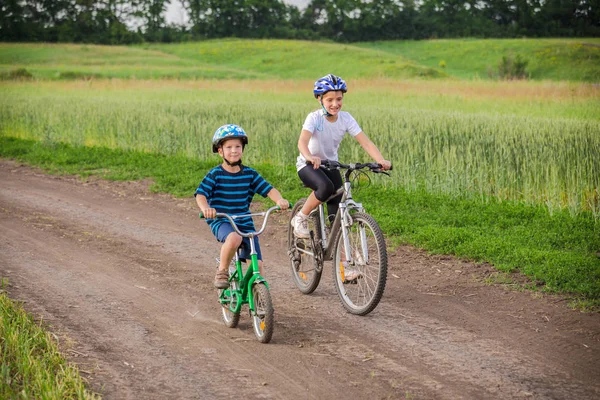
xmin=0 ymin=38 xmax=600 ymax=83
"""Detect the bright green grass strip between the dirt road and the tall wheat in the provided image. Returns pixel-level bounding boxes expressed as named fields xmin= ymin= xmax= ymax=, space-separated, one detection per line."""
xmin=0 ymin=137 xmax=600 ymax=309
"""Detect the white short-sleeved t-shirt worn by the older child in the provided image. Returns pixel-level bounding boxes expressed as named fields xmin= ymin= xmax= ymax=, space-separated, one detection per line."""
xmin=296 ymin=109 xmax=362 ymax=171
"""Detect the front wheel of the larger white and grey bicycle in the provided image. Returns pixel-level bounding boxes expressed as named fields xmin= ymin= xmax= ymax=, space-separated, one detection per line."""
xmin=333 ymin=212 xmax=387 ymax=315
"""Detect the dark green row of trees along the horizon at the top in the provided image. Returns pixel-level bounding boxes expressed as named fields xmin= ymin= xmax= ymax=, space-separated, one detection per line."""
xmin=0 ymin=0 xmax=600 ymax=44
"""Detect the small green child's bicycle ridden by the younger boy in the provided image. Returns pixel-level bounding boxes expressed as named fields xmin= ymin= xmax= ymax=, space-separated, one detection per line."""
xmin=200 ymin=204 xmax=291 ymax=343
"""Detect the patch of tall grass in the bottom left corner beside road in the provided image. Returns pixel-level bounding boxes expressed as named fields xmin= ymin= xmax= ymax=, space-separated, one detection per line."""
xmin=0 ymin=280 xmax=99 ymax=399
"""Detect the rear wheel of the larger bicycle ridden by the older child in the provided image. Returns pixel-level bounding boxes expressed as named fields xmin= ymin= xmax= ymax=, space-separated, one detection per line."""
xmin=288 ymin=198 xmax=323 ymax=294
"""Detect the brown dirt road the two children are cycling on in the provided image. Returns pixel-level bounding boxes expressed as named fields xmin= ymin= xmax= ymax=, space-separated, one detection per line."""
xmin=0 ymin=161 xmax=600 ymax=399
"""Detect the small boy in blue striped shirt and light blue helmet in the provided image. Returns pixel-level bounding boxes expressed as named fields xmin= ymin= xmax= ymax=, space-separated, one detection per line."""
xmin=194 ymin=124 xmax=289 ymax=289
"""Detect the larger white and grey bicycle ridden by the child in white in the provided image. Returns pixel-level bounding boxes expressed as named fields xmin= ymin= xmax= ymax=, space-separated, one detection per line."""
xmin=288 ymin=160 xmax=389 ymax=315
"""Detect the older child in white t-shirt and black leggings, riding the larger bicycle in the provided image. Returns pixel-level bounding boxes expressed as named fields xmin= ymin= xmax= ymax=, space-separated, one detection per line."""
xmin=292 ymin=74 xmax=392 ymax=238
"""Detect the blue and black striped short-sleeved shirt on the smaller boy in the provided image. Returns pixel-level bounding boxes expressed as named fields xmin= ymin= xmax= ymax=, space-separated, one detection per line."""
xmin=194 ymin=165 xmax=273 ymax=236
